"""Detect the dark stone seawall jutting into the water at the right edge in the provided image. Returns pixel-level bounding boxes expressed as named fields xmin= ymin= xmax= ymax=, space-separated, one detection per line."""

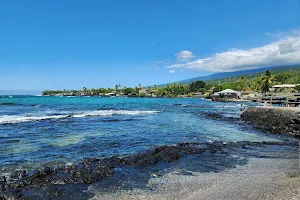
xmin=241 ymin=107 xmax=300 ymax=138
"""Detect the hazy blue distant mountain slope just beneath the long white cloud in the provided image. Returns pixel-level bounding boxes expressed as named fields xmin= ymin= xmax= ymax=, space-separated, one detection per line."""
xmin=159 ymin=65 xmax=300 ymax=86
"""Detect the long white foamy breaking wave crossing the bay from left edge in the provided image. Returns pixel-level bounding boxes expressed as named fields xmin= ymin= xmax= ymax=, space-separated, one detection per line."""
xmin=0 ymin=110 xmax=158 ymax=124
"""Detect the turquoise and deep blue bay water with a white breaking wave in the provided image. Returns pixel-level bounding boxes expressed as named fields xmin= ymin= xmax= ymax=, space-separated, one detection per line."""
xmin=0 ymin=96 xmax=286 ymax=174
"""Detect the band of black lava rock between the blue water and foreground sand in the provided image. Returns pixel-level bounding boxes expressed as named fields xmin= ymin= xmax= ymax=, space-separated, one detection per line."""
xmin=0 ymin=141 xmax=298 ymax=200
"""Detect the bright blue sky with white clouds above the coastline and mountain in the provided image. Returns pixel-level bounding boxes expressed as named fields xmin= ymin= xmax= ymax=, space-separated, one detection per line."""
xmin=0 ymin=0 xmax=300 ymax=93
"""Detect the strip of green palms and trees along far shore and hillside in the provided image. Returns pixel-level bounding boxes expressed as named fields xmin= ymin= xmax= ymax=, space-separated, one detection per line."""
xmin=42 ymin=67 xmax=300 ymax=97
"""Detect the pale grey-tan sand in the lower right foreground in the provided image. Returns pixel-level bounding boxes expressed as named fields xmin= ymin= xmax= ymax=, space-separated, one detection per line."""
xmin=91 ymin=158 xmax=300 ymax=200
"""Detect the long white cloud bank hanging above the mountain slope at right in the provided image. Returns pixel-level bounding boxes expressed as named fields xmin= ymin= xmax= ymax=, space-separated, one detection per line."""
xmin=167 ymin=34 xmax=300 ymax=72
